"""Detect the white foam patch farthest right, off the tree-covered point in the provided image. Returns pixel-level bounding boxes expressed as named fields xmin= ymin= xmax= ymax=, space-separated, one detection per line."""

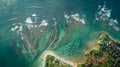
xmin=95 ymin=4 xmax=120 ymax=31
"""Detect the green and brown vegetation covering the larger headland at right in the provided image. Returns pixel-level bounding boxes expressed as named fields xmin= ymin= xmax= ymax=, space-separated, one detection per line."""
xmin=78 ymin=33 xmax=120 ymax=67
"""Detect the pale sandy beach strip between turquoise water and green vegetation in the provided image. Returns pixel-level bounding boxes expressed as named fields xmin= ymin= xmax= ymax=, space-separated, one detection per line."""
xmin=32 ymin=32 xmax=119 ymax=67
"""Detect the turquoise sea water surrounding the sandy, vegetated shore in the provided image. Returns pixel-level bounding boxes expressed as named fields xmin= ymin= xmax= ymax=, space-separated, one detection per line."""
xmin=0 ymin=0 xmax=120 ymax=67
